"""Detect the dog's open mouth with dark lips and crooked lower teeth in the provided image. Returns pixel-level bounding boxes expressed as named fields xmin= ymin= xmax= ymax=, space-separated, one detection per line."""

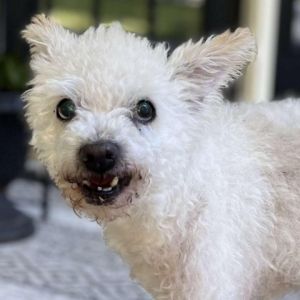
xmin=77 ymin=173 xmax=132 ymax=205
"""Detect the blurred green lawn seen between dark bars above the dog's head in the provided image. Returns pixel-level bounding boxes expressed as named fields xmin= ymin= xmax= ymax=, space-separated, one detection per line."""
xmin=51 ymin=0 xmax=202 ymax=41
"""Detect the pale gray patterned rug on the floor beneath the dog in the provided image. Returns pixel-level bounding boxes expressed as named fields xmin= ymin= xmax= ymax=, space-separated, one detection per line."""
xmin=0 ymin=180 xmax=150 ymax=300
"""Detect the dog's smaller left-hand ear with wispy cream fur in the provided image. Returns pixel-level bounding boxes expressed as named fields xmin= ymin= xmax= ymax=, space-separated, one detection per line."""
xmin=21 ymin=14 xmax=70 ymax=59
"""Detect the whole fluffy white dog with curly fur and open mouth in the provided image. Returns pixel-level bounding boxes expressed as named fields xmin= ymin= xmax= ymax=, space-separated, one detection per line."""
xmin=23 ymin=15 xmax=300 ymax=300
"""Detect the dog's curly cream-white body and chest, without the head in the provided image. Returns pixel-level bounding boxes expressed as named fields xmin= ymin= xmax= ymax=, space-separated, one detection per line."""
xmin=106 ymin=100 xmax=300 ymax=299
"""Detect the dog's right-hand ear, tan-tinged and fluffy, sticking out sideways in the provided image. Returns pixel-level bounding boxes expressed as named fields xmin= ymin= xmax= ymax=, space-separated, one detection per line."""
xmin=169 ymin=28 xmax=256 ymax=95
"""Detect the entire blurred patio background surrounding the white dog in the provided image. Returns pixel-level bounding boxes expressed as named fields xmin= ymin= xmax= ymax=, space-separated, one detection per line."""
xmin=0 ymin=0 xmax=300 ymax=300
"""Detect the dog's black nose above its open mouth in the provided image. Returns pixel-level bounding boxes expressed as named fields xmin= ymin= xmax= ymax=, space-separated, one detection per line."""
xmin=79 ymin=141 xmax=120 ymax=174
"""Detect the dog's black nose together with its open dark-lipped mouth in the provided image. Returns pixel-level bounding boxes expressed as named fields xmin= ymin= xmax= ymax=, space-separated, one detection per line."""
xmin=77 ymin=141 xmax=132 ymax=205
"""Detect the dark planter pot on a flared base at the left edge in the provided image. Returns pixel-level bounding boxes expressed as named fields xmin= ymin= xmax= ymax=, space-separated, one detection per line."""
xmin=0 ymin=92 xmax=34 ymax=242
